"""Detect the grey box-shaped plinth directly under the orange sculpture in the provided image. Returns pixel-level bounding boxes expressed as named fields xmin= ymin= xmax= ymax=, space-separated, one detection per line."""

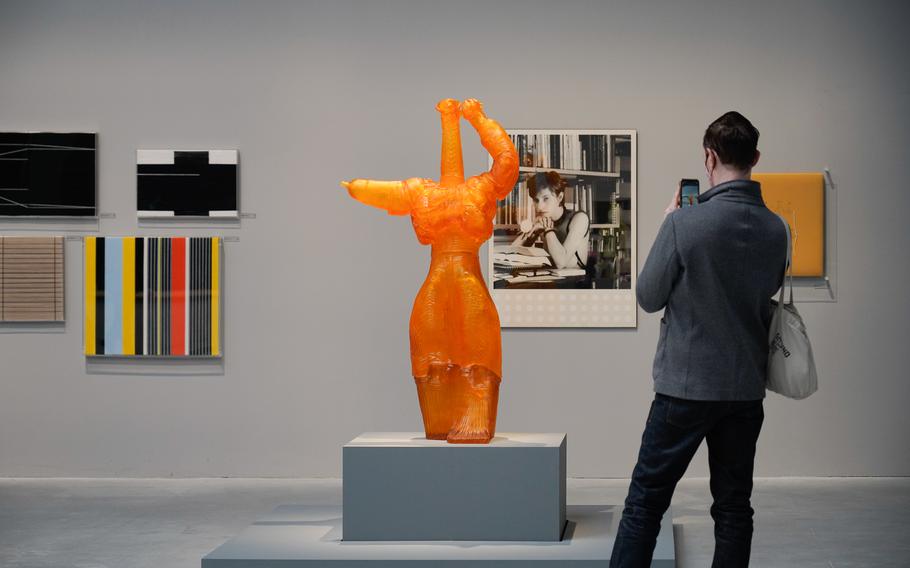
xmin=342 ymin=432 xmax=566 ymax=542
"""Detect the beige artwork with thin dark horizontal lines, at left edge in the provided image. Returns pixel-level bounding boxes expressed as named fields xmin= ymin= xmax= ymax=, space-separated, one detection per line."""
xmin=0 ymin=237 xmax=63 ymax=322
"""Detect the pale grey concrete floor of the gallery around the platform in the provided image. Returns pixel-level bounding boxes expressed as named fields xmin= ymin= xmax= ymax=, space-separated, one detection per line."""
xmin=0 ymin=478 xmax=910 ymax=568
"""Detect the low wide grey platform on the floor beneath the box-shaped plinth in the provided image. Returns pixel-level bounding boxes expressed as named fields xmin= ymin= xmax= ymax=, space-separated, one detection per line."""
xmin=202 ymin=505 xmax=676 ymax=568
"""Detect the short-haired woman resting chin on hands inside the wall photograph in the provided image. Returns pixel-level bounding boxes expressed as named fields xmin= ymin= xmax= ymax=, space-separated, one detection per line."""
xmin=512 ymin=171 xmax=591 ymax=268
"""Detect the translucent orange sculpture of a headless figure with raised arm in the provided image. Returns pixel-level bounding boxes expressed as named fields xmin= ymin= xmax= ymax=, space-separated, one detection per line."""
xmin=342 ymin=99 xmax=518 ymax=444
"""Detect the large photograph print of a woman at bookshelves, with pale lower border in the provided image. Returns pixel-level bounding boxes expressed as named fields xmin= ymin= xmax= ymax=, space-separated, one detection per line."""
xmin=487 ymin=130 xmax=637 ymax=327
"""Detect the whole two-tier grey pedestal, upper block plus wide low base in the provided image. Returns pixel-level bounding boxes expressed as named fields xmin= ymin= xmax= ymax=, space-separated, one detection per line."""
xmin=202 ymin=433 xmax=676 ymax=568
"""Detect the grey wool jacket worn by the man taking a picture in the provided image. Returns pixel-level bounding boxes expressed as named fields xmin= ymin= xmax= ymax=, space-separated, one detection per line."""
xmin=636 ymin=180 xmax=787 ymax=400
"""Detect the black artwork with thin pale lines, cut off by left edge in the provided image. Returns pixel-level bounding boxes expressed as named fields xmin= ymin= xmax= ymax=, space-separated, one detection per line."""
xmin=0 ymin=132 xmax=96 ymax=217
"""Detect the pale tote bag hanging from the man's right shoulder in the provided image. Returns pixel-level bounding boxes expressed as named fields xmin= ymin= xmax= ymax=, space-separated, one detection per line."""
xmin=767 ymin=217 xmax=818 ymax=399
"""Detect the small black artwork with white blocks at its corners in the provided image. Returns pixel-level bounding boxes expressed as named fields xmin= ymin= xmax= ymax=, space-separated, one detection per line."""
xmin=136 ymin=150 xmax=238 ymax=218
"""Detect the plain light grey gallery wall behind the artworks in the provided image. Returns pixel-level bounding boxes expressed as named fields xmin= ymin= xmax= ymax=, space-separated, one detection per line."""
xmin=0 ymin=0 xmax=910 ymax=477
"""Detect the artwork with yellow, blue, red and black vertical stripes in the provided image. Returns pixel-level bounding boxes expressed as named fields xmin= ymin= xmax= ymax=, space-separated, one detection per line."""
xmin=85 ymin=237 xmax=221 ymax=357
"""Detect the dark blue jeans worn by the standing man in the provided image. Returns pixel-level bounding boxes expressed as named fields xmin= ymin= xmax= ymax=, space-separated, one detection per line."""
xmin=610 ymin=394 xmax=765 ymax=568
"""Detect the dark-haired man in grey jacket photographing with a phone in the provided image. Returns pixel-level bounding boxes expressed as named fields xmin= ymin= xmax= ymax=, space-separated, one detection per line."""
xmin=610 ymin=112 xmax=787 ymax=568
